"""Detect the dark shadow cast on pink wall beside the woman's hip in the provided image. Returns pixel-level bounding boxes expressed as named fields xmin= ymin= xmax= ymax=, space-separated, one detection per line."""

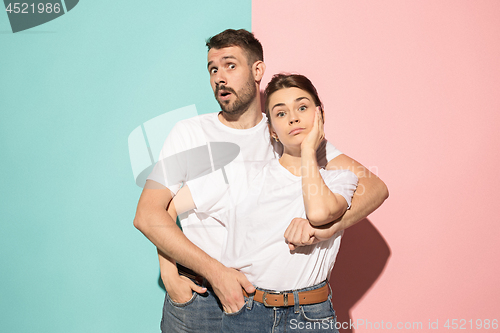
xmin=330 ymin=219 xmax=391 ymax=333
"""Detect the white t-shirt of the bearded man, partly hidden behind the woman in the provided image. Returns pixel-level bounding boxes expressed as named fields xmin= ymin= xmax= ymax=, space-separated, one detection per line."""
xmin=148 ymin=113 xmax=341 ymax=261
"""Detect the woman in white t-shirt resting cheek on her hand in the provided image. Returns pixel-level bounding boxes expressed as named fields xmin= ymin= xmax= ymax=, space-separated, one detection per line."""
xmin=163 ymin=74 xmax=357 ymax=332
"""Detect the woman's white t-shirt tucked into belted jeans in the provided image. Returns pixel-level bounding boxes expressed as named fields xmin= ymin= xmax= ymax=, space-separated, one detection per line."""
xmin=187 ymin=159 xmax=358 ymax=291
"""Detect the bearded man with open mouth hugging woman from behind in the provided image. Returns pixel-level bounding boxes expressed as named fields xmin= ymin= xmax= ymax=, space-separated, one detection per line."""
xmin=134 ymin=30 xmax=388 ymax=332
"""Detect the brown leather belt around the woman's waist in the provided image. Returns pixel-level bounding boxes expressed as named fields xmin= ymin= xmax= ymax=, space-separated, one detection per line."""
xmin=243 ymin=284 xmax=330 ymax=307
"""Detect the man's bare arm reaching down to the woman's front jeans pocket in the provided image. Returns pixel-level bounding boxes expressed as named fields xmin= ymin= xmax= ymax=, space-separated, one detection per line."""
xmin=134 ymin=180 xmax=254 ymax=313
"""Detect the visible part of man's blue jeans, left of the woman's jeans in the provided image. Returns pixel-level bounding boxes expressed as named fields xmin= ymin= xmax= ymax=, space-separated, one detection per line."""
xmin=160 ymin=278 xmax=223 ymax=333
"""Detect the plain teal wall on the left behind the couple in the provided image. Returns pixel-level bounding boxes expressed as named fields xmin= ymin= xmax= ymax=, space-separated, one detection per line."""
xmin=0 ymin=0 xmax=251 ymax=333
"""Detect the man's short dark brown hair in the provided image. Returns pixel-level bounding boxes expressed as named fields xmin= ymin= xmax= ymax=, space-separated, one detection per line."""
xmin=207 ymin=29 xmax=264 ymax=66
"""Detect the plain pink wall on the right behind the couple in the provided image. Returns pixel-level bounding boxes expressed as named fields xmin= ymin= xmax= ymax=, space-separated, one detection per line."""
xmin=252 ymin=0 xmax=500 ymax=332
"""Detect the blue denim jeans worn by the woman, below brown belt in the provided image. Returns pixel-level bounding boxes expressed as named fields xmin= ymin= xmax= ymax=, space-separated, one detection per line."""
xmin=222 ymin=281 xmax=338 ymax=333
